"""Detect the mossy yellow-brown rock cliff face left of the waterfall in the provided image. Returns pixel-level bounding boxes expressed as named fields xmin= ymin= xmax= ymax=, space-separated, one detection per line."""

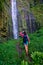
xmin=0 ymin=0 xmax=12 ymax=39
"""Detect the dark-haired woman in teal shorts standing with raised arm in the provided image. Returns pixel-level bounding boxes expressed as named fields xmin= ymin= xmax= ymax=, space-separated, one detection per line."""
xmin=20 ymin=31 xmax=30 ymax=55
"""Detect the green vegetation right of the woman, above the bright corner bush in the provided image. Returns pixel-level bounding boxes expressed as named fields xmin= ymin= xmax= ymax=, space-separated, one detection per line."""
xmin=29 ymin=28 xmax=43 ymax=53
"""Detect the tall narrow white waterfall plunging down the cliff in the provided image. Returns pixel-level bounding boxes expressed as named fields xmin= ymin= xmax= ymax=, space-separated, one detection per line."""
xmin=11 ymin=0 xmax=18 ymax=39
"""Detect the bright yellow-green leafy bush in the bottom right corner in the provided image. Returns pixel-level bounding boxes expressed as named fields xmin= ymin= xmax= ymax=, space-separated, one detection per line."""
xmin=31 ymin=52 xmax=43 ymax=65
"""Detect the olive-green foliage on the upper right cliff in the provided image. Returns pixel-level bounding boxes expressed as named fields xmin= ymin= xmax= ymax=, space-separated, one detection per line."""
xmin=31 ymin=4 xmax=43 ymax=26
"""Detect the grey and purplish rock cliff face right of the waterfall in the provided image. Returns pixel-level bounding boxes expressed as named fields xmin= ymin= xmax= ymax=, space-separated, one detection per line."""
xmin=17 ymin=0 xmax=36 ymax=33
